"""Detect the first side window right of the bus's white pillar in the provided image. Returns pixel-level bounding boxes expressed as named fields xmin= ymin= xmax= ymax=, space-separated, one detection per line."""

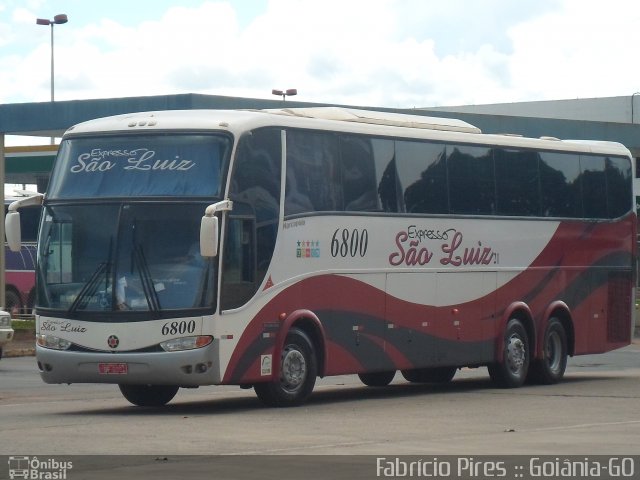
xmin=284 ymin=130 xmax=343 ymax=215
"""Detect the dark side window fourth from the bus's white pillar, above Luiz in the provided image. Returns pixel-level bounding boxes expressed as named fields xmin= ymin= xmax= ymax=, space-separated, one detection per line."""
xmin=447 ymin=146 xmax=496 ymax=215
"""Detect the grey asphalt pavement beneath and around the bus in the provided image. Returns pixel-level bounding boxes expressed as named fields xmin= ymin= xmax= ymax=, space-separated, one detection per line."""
xmin=0 ymin=344 xmax=640 ymax=480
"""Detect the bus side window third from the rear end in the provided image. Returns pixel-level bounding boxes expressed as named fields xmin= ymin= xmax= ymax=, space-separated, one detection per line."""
xmin=539 ymin=152 xmax=584 ymax=218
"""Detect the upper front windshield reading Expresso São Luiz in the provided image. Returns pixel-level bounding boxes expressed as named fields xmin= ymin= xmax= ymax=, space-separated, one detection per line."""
xmin=47 ymin=134 xmax=231 ymax=200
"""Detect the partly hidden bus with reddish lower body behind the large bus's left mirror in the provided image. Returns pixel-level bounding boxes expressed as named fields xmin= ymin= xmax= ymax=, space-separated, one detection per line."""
xmin=4 ymin=197 xmax=40 ymax=317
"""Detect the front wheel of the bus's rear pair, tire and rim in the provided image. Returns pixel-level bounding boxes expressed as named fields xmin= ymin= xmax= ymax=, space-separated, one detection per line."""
xmin=489 ymin=318 xmax=531 ymax=388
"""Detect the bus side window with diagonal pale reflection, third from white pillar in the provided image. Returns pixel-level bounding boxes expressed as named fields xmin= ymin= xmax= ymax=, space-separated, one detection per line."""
xmin=396 ymin=141 xmax=449 ymax=213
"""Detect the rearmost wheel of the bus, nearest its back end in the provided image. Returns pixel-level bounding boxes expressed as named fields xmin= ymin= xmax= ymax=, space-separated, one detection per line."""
xmin=527 ymin=318 xmax=568 ymax=385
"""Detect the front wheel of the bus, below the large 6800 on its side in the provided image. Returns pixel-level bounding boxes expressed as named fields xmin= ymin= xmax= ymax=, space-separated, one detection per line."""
xmin=253 ymin=328 xmax=318 ymax=407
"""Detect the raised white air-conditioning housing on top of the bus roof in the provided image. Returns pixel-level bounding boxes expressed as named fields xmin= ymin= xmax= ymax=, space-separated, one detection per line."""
xmin=266 ymin=107 xmax=482 ymax=133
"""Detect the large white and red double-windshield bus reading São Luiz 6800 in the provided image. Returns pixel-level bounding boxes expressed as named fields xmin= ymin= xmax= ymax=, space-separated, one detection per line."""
xmin=7 ymin=107 xmax=636 ymax=406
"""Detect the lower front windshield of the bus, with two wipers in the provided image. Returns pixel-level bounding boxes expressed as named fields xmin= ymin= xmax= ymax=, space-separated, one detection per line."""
xmin=38 ymin=203 xmax=215 ymax=316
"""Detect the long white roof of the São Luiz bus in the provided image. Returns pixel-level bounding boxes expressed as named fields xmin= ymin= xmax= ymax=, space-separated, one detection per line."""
xmin=64 ymin=107 xmax=631 ymax=156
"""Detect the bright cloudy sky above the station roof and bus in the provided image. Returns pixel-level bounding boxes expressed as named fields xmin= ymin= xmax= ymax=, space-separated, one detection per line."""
xmin=0 ymin=0 xmax=640 ymax=118
